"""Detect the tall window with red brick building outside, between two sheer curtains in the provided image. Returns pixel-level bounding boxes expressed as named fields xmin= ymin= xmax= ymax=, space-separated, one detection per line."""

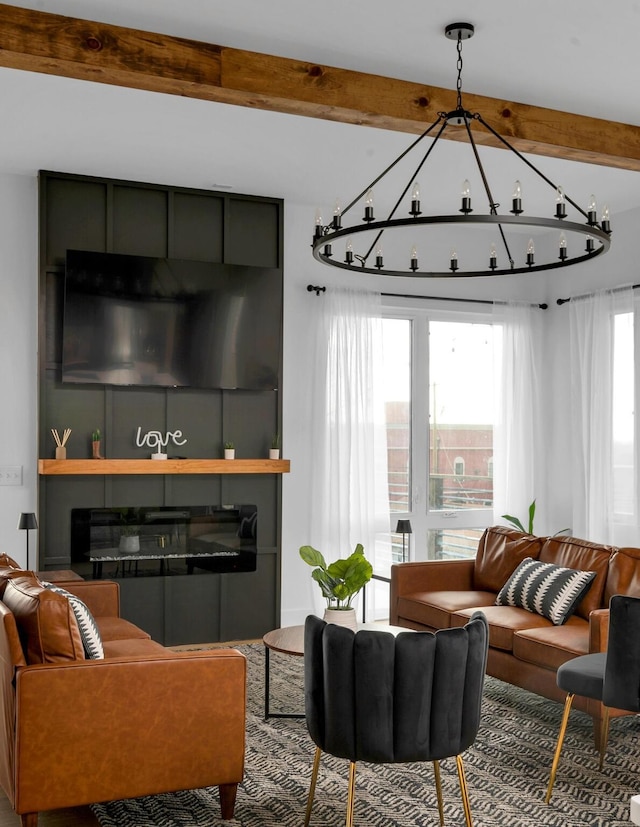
xmin=380 ymin=308 xmax=499 ymax=574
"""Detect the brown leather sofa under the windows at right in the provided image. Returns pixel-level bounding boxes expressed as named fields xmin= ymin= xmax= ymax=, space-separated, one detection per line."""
xmin=390 ymin=526 xmax=640 ymax=738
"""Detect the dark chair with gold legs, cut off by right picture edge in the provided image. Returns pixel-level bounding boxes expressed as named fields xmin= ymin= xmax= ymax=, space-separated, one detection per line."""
xmin=546 ymin=594 xmax=640 ymax=804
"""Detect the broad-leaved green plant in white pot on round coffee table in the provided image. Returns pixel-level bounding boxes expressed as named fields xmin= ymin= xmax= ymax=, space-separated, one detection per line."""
xmin=300 ymin=543 xmax=373 ymax=629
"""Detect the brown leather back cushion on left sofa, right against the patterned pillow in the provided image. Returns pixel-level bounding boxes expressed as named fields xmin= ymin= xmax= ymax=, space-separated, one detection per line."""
xmin=2 ymin=573 xmax=84 ymax=663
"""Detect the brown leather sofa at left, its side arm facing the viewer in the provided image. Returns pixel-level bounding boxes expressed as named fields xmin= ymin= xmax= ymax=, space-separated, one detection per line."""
xmin=0 ymin=555 xmax=246 ymax=827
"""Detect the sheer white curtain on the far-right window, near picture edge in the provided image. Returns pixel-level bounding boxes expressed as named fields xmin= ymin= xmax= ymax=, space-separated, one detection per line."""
xmin=570 ymin=287 xmax=633 ymax=543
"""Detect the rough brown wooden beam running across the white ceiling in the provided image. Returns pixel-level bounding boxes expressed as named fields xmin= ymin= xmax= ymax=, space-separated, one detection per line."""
xmin=0 ymin=4 xmax=640 ymax=170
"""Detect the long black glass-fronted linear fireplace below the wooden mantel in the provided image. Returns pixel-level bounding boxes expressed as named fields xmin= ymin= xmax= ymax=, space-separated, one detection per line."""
xmin=71 ymin=505 xmax=258 ymax=579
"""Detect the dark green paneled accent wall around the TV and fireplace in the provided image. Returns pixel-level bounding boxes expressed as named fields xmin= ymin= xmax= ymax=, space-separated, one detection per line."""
xmin=39 ymin=172 xmax=283 ymax=644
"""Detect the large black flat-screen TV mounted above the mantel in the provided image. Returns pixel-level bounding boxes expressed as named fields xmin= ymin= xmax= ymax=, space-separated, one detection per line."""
xmin=62 ymin=250 xmax=282 ymax=390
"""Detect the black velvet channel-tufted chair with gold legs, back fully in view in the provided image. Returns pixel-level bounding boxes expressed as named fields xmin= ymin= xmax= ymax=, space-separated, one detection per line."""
xmin=304 ymin=613 xmax=489 ymax=827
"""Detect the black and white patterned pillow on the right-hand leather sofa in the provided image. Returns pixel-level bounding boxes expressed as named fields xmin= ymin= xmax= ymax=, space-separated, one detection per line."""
xmin=496 ymin=557 xmax=596 ymax=626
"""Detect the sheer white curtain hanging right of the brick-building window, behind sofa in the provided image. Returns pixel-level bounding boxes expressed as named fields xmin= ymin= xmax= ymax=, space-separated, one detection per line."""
xmin=493 ymin=303 xmax=544 ymax=530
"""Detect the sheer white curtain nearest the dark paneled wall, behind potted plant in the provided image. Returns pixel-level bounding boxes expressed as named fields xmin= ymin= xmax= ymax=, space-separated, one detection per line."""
xmin=308 ymin=287 xmax=389 ymax=609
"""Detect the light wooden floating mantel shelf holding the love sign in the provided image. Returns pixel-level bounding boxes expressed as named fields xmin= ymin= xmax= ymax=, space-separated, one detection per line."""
xmin=38 ymin=459 xmax=290 ymax=476
